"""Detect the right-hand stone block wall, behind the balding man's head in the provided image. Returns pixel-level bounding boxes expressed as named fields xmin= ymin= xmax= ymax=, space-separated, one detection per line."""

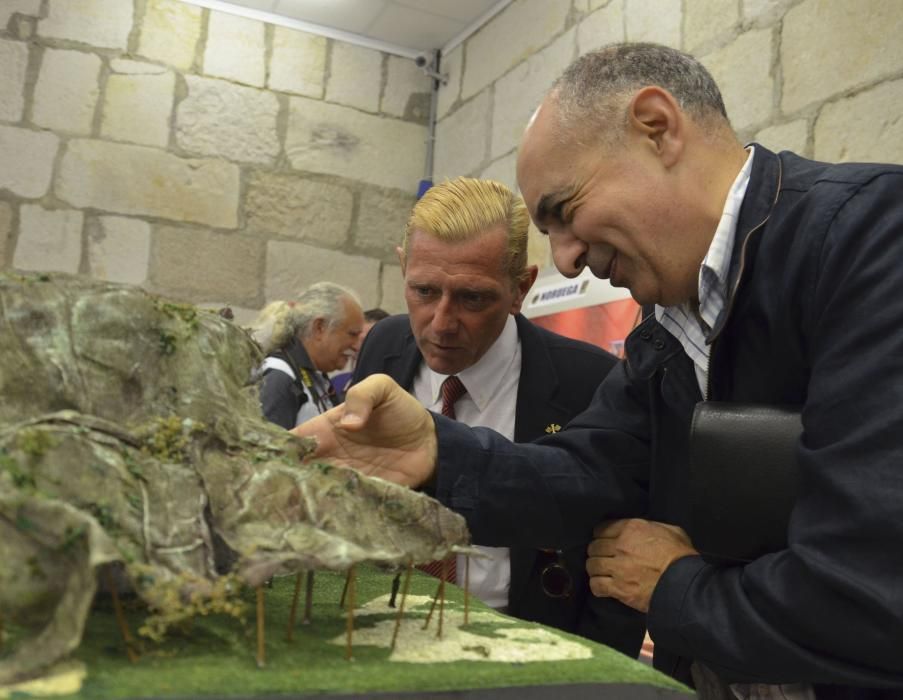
xmin=435 ymin=0 xmax=903 ymax=265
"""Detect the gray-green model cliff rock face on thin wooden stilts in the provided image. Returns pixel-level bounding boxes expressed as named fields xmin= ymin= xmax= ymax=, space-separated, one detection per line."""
xmin=0 ymin=274 xmax=468 ymax=683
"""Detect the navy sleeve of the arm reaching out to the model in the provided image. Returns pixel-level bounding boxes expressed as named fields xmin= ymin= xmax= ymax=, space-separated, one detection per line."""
xmin=434 ymin=363 xmax=649 ymax=549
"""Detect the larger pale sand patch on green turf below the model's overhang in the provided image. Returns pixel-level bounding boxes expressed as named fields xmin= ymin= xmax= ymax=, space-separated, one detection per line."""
xmin=330 ymin=595 xmax=593 ymax=664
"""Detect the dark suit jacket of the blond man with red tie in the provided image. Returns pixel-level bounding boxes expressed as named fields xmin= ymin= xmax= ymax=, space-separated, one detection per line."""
xmin=353 ymin=315 xmax=645 ymax=657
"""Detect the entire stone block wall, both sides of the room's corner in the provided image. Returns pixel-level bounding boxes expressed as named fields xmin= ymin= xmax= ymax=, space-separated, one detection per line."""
xmin=0 ymin=0 xmax=903 ymax=317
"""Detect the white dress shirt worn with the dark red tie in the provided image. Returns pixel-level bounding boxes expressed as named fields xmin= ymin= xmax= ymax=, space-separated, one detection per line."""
xmin=413 ymin=315 xmax=521 ymax=608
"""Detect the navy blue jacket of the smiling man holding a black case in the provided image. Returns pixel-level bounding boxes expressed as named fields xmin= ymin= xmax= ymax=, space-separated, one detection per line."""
xmin=435 ymin=145 xmax=903 ymax=697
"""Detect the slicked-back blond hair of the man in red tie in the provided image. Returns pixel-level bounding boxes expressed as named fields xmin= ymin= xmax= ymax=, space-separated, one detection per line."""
xmin=402 ymin=177 xmax=530 ymax=285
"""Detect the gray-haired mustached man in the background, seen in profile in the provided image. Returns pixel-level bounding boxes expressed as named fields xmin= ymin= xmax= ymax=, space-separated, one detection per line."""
xmin=253 ymin=282 xmax=364 ymax=429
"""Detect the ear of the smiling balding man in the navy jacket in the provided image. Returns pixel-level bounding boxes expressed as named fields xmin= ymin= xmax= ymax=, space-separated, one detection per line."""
xmin=627 ymin=85 xmax=686 ymax=168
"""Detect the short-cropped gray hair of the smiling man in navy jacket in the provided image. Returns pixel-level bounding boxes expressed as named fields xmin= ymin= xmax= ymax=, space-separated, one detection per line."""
xmin=551 ymin=43 xmax=730 ymax=143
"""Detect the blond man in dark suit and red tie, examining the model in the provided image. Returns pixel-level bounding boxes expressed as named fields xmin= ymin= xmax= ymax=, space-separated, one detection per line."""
xmin=355 ymin=178 xmax=643 ymax=656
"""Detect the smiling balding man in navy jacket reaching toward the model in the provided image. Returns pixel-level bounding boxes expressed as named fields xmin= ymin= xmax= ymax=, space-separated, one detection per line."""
xmin=297 ymin=44 xmax=903 ymax=700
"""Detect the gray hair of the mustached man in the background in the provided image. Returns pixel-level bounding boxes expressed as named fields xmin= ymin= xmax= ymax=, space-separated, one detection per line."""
xmin=249 ymin=282 xmax=361 ymax=354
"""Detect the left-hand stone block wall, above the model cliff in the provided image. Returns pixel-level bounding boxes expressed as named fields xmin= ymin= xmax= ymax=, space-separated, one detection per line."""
xmin=0 ymin=0 xmax=431 ymax=320
